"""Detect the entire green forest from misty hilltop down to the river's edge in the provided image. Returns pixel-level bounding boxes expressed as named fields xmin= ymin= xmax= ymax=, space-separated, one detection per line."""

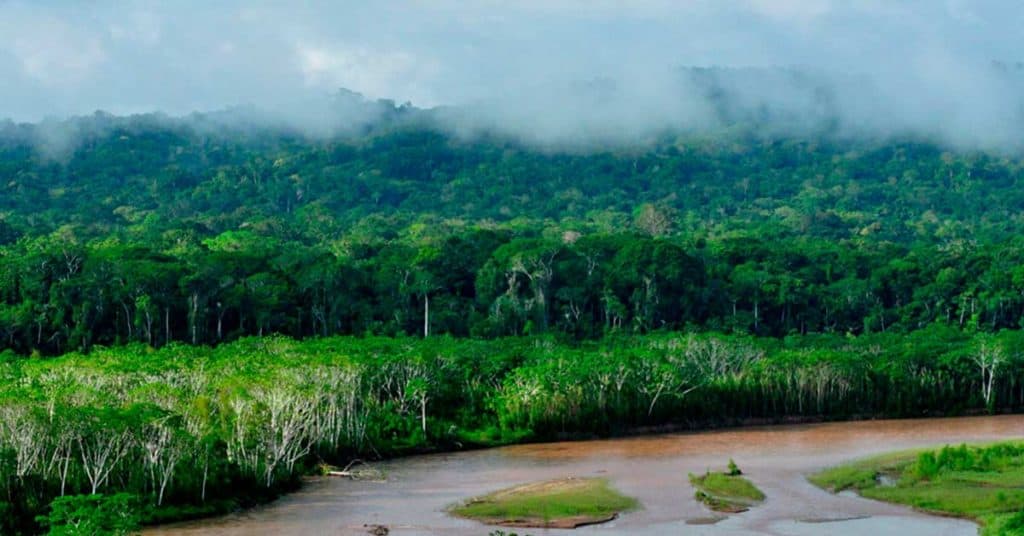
xmin=6 ymin=101 xmax=1024 ymax=534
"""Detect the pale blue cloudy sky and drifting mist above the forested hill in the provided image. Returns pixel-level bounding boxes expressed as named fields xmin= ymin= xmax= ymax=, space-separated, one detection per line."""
xmin=0 ymin=0 xmax=1024 ymax=155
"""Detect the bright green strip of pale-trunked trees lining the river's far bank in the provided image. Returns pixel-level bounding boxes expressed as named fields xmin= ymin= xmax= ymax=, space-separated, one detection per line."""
xmin=0 ymin=326 xmax=1020 ymax=534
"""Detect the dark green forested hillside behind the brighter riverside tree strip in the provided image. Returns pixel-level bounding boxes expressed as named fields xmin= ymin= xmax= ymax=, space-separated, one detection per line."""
xmin=0 ymin=101 xmax=1024 ymax=354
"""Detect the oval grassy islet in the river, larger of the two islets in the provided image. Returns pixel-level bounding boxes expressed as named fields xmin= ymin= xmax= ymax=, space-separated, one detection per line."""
xmin=451 ymin=479 xmax=638 ymax=528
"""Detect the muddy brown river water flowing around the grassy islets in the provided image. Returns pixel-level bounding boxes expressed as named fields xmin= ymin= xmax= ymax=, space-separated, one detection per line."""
xmin=145 ymin=415 xmax=1024 ymax=536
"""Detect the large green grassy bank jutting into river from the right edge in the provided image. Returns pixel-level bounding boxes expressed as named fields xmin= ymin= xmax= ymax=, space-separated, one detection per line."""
xmin=809 ymin=442 xmax=1024 ymax=536
